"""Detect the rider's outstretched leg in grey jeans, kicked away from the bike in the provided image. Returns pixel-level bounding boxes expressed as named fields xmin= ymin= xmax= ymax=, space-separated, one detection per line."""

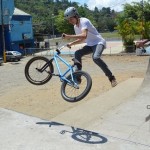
xmin=92 ymin=44 xmax=117 ymax=87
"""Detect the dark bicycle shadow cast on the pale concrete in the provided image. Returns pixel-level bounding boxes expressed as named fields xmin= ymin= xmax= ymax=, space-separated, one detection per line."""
xmin=36 ymin=122 xmax=108 ymax=144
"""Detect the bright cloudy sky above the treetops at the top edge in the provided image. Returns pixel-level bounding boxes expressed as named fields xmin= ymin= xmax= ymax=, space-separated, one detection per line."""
xmin=71 ymin=0 xmax=147 ymax=11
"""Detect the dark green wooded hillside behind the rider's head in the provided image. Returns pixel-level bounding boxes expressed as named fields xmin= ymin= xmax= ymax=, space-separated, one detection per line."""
xmin=15 ymin=0 xmax=117 ymax=34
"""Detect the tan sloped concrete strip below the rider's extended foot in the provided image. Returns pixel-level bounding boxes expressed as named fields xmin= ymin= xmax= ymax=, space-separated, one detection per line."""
xmin=52 ymin=78 xmax=143 ymax=129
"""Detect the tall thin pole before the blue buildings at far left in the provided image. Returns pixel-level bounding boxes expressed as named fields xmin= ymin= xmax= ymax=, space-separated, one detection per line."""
xmin=1 ymin=0 xmax=6 ymax=63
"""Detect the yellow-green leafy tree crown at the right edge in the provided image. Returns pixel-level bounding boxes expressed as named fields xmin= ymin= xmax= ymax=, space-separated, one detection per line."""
xmin=117 ymin=0 xmax=150 ymax=39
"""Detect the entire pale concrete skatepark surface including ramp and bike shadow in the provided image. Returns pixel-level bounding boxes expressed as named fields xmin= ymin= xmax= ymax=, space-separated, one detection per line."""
xmin=0 ymin=49 xmax=150 ymax=150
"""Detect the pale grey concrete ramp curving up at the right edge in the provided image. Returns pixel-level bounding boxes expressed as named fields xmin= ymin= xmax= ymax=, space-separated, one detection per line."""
xmin=87 ymin=60 xmax=150 ymax=150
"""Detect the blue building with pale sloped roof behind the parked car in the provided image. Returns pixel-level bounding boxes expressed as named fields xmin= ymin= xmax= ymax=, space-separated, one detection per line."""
xmin=7 ymin=8 xmax=34 ymax=54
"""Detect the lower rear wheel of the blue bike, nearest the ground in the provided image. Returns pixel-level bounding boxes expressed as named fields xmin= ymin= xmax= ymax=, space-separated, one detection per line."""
xmin=61 ymin=71 xmax=92 ymax=102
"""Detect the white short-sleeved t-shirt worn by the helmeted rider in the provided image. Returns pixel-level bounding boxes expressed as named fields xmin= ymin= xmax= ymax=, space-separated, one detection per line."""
xmin=74 ymin=18 xmax=106 ymax=48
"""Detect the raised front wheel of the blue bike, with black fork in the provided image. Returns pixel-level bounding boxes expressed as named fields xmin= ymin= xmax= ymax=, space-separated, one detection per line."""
xmin=25 ymin=56 xmax=54 ymax=85
